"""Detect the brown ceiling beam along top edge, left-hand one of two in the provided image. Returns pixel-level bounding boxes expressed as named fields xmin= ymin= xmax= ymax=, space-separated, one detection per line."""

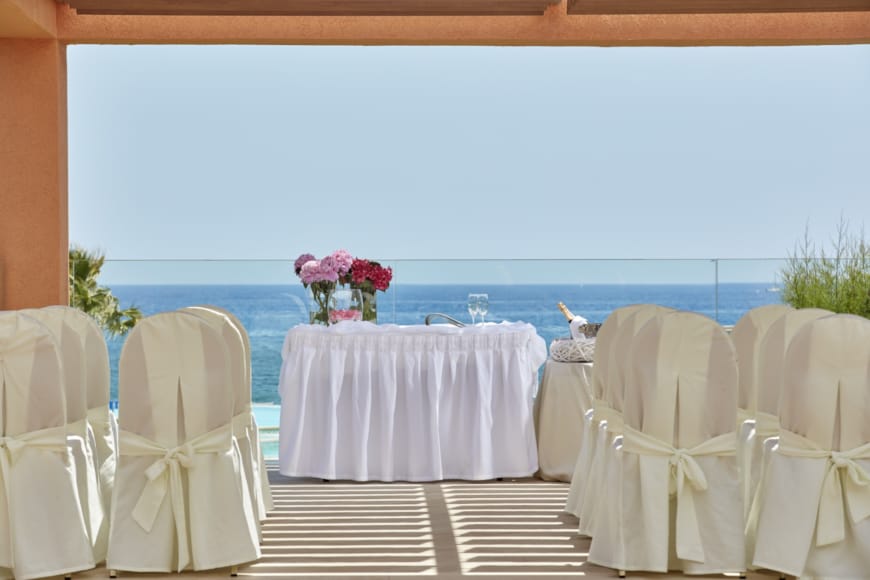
xmin=66 ymin=0 xmax=561 ymax=16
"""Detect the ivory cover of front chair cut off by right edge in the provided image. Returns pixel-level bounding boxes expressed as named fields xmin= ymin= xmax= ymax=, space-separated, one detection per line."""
xmin=753 ymin=314 xmax=870 ymax=578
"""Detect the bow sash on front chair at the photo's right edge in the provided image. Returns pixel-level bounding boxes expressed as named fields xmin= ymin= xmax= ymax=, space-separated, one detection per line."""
xmin=777 ymin=429 xmax=870 ymax=546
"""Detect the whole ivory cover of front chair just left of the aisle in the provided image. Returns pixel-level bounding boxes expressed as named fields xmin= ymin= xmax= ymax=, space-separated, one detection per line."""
xmin=106 ymin=312 xmax=260 ymax=572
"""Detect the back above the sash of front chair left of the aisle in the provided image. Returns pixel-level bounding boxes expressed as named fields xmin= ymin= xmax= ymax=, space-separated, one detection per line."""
xmin=118 ymin=312 xmax=234 ymax=448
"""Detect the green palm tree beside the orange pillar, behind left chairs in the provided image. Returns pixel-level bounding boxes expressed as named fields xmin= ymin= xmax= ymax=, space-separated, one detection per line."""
xmin=69 ymin=246 xmax=142 ymax=337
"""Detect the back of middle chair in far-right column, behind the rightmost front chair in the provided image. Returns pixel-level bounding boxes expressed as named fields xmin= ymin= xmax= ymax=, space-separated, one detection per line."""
xmin=756 ymin=308 xmax=833 ymax=422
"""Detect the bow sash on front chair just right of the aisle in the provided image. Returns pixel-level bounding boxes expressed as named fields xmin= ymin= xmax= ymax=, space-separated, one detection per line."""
xmin=622 ymin=425 xmax=737 ymax=562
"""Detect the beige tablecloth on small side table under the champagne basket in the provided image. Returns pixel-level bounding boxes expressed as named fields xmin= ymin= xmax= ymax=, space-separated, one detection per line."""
xmin=535 ymin=360 xmax=592 ymax=481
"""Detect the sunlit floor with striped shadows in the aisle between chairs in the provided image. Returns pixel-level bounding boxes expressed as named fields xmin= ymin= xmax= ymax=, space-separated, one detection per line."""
xmin=77 ymin=466 xmax=776 ymax=580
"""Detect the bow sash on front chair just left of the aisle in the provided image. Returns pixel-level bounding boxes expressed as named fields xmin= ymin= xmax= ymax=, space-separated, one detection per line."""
xmin=118 ymin=423 xmax=232 ymax=572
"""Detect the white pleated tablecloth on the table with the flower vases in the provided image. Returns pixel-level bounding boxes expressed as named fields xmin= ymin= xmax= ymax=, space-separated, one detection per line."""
xmin=279 ymin=322 xmax=546 ymax=481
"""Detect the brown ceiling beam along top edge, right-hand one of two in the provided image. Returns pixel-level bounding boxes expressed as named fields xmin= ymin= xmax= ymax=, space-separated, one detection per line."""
xmin=568 ymin=0 xmax=870 ymax=15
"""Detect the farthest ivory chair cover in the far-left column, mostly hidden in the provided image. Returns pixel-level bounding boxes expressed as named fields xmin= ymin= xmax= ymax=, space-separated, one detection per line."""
xmin=45 ymin=306 xmax=118 ymax=562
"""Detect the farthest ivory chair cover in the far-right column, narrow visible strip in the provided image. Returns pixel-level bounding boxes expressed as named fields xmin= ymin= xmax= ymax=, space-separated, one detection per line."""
xmin=731 ymin=304 xmax=792 ymax=511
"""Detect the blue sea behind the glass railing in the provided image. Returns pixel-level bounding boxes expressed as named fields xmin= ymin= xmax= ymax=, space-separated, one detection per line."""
xmin=109 ymin=284 xmax=780 ymax=403
